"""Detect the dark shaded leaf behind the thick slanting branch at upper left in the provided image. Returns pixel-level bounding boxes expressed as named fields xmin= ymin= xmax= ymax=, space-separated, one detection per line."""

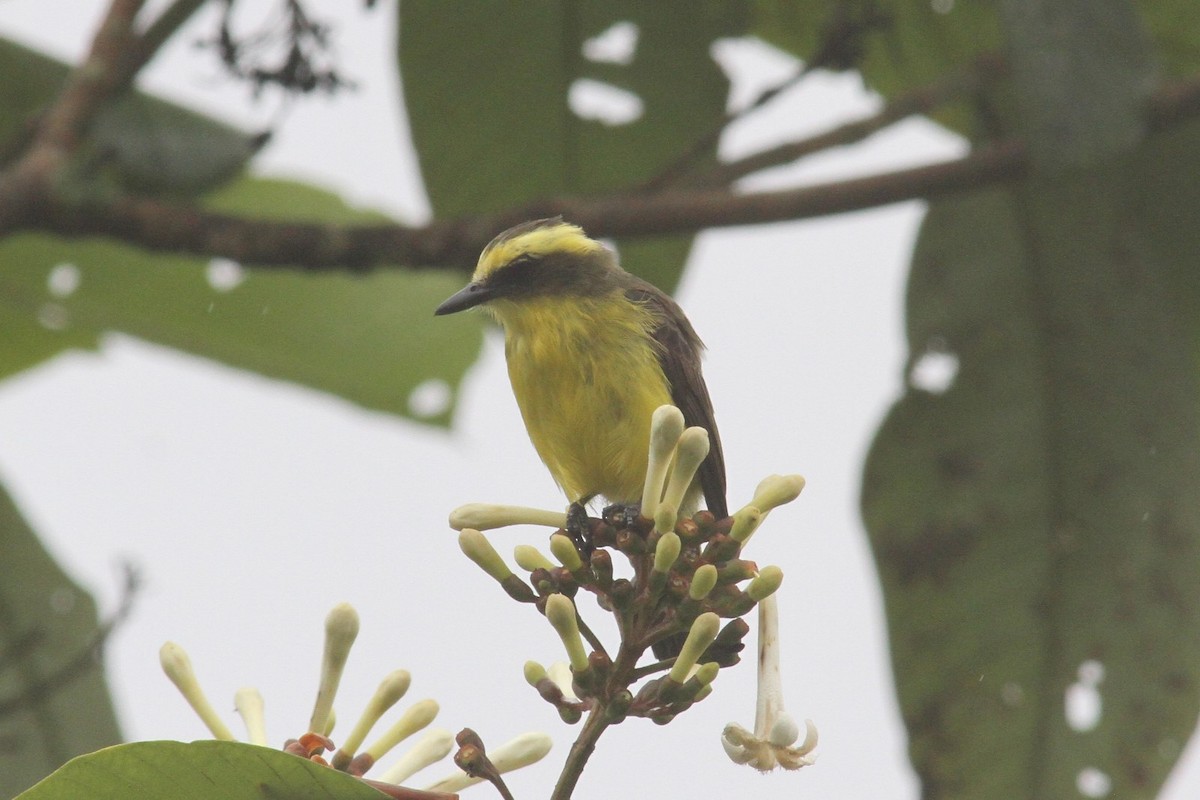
xmin=0 ymin=40 xmax=262 ymax=194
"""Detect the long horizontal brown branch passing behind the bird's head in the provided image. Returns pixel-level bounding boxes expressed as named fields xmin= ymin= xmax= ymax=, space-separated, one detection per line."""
xmin=23 ymin=142 xmax=1026 ymax=270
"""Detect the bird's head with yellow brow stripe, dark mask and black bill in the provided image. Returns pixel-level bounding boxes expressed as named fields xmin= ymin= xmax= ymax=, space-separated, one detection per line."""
xmin=433 ymin=217 xmax=620 ymax=314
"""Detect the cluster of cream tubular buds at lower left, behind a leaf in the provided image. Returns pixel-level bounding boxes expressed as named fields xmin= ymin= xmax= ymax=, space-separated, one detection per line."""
xmin=158 ymin=603 xmax=551 ymax=800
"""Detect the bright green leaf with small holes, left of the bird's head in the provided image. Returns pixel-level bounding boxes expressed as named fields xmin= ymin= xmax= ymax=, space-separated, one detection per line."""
xmin=0 ymin=179 xmax=481 ymax=425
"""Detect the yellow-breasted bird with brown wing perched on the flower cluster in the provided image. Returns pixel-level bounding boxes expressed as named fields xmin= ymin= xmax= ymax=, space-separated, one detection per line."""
xmin=434 ymin=217 xmax=728 ymax=519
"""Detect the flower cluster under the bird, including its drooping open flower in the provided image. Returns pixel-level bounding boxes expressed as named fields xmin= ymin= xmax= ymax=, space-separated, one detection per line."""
xmin=450 ymin=407 xmax=816 ymax=770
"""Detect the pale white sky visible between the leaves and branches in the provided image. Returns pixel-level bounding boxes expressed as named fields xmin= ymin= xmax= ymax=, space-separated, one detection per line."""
xmin=0 ymin=0 xmax=1200 ymax=800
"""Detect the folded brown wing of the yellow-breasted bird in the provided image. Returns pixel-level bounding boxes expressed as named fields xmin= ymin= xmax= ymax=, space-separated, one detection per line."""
xmin=625 ymin=276 xmax=728 ymax=519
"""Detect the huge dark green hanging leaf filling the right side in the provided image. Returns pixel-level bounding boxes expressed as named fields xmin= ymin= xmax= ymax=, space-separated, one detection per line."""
xmin=863 ymin=118 xmax=1200 ymax=800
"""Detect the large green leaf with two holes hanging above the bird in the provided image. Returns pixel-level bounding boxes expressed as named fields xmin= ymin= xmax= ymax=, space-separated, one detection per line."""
xmin=400 ymin=0 xmax=744 ymax=288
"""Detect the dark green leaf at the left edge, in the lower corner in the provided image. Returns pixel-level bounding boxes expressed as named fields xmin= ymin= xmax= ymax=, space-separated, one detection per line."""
xmin=0 ymin=479 xmax=121 ymax=798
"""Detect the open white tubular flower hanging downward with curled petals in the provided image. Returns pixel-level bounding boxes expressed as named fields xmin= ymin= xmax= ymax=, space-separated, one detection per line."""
xmin=721 ymin=595 xmax=817 ymax=772
